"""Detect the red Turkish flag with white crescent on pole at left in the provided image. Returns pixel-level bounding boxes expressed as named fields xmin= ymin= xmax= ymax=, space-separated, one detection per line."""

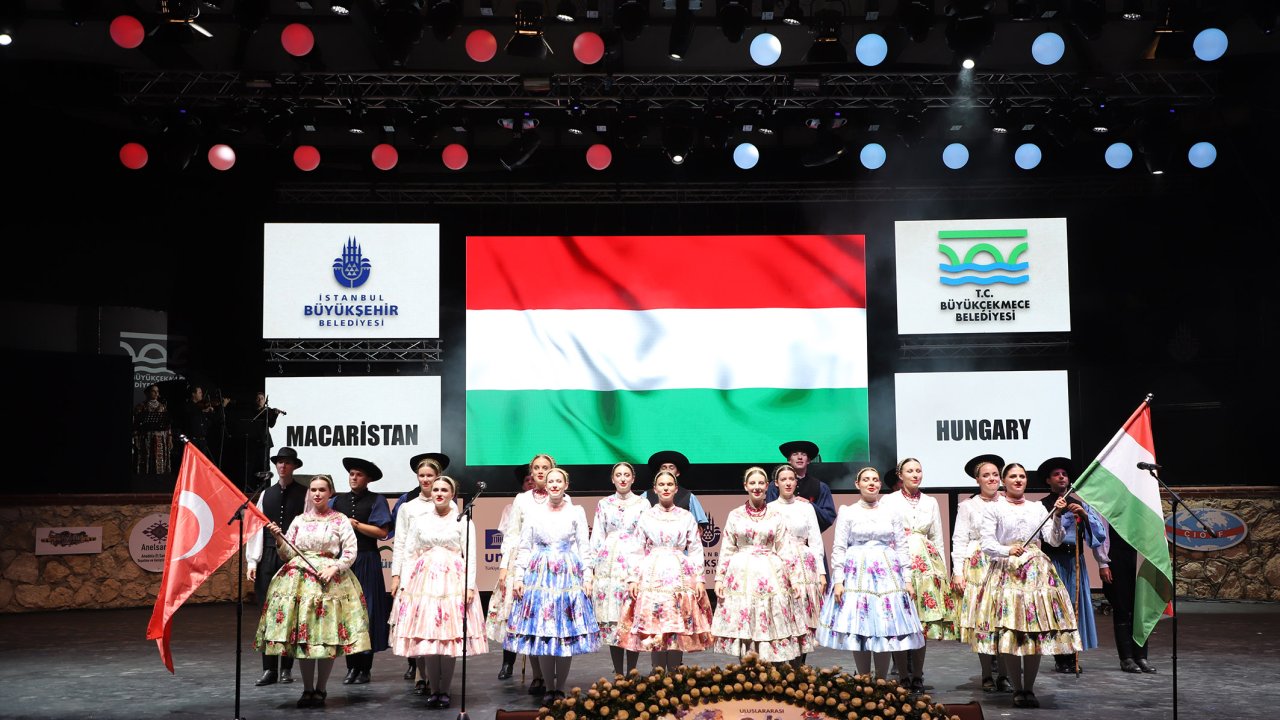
xmin=147 ymin=442 xmax=269 ymax=673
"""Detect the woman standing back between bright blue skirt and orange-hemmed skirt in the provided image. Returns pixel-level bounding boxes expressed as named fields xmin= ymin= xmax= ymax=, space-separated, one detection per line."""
xmin=590 ymin=462 xmax=649 ymax=675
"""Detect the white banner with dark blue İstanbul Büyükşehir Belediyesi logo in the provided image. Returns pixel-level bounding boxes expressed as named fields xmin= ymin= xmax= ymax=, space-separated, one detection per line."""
xmin=262 ymin=223 xmax=440 ymax=340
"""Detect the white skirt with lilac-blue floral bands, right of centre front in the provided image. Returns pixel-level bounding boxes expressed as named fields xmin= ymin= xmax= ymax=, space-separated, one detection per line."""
xmin=818 ymin=544 xmax=924 ymax=652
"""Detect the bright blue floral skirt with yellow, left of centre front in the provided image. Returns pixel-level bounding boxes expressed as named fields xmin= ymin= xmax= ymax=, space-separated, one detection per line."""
xmin=502 ymin=548 xmax=600 ymax=657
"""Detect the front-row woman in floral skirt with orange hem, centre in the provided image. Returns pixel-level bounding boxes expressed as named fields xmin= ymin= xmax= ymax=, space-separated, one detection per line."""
xmin=618 ymin=470 xmax=712 ymax=670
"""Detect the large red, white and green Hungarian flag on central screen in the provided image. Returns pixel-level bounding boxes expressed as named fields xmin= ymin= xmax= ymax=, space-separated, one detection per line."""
xmin=467 ymin=236 xmax=868 ymax=465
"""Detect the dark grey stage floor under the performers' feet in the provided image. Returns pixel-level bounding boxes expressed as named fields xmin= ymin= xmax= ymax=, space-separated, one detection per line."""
xmin=0 ymin=602 xmax=1280 ymax=720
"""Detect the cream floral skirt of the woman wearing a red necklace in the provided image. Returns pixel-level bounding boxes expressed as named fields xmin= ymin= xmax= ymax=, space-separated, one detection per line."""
xmin=712 ymin=552 xmax=809 ymax=662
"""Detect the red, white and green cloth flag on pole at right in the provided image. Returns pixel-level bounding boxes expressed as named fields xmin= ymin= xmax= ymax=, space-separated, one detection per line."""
xmin=1075 ymin=401 xmax=1174 ymax=644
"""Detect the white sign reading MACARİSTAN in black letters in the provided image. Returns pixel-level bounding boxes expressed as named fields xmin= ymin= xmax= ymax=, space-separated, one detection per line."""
xmin=266 ymin=375 xmax=440 ymax=495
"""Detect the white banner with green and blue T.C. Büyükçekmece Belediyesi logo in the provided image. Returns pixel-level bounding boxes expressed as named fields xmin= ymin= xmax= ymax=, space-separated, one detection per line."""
xmin=895 ymin=218 xmax=1071 ymax=334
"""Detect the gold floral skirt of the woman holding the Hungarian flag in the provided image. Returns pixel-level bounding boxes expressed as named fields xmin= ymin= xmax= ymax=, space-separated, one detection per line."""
xmin=969 ymin=546 xmax=1082 ymax=655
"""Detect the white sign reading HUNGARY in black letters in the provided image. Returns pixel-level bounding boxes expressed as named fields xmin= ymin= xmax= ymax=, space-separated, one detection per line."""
xmin=882 ymin=370 xmax=1071 ymax=488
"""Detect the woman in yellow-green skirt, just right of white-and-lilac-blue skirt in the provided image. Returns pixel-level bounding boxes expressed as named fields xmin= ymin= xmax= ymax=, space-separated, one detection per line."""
xmin=884 ymin=457 xmax=956 ymax=692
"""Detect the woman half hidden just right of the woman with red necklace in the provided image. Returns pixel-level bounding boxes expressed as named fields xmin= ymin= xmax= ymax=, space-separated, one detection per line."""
xmin=769 ymin=464 xmax=827 ymax=665
